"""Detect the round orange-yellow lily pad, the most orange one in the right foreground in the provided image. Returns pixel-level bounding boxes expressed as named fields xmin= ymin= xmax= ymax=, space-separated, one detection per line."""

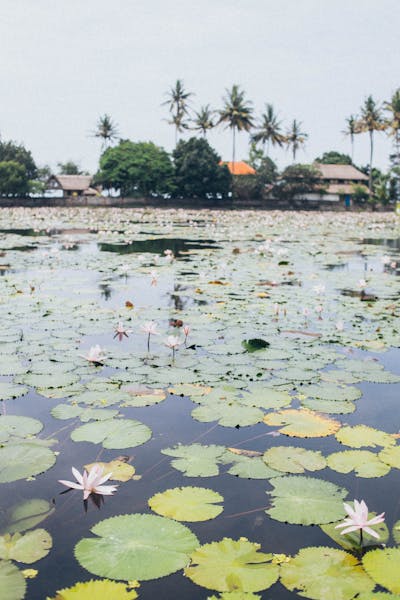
xmin=264 ymin=408 xmax=340 ymax=437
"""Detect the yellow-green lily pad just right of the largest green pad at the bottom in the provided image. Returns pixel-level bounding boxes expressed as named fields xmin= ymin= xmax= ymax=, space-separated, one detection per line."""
xmin=185 ymin=538 xmax=279 ymax=592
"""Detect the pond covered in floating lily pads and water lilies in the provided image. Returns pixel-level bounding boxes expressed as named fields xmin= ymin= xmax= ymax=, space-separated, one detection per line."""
xmin=0 ymin=208 xmax=400 ymax=600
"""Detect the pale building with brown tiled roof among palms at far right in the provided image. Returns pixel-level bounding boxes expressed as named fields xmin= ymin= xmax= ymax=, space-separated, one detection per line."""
xmin=305 ymin=163 xmax=368 ymax=206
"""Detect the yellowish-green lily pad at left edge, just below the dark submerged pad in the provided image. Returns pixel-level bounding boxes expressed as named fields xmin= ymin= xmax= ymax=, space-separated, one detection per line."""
xmin=0 ymin=529 xmax=52 ymax=565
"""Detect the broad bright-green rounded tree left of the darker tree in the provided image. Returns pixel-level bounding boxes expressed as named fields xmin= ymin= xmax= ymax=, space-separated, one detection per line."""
xmin=96 ymin=140 xmax=173 ymax=196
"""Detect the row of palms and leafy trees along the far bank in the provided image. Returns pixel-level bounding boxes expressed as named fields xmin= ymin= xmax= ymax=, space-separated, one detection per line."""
xmin=0 ymin=79 xmax=400 ymax=205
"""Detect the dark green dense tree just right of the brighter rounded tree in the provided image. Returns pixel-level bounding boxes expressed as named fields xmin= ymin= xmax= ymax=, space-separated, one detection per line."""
xmin=173 ymin=138 xmax=231 ymax=198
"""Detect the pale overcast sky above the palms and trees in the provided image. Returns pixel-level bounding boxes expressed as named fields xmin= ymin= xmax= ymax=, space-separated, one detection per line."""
xmin=0 ymin=0 xmax=400 ymax=171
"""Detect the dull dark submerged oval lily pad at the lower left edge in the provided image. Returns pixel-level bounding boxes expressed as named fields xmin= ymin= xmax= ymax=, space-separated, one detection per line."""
xmin=1 ymin=498 xmax=55 ymax=533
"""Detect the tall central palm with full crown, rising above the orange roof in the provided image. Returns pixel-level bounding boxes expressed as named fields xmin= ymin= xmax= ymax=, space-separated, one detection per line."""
xmin=218 ymin=84 xmax=253 ymax=175
